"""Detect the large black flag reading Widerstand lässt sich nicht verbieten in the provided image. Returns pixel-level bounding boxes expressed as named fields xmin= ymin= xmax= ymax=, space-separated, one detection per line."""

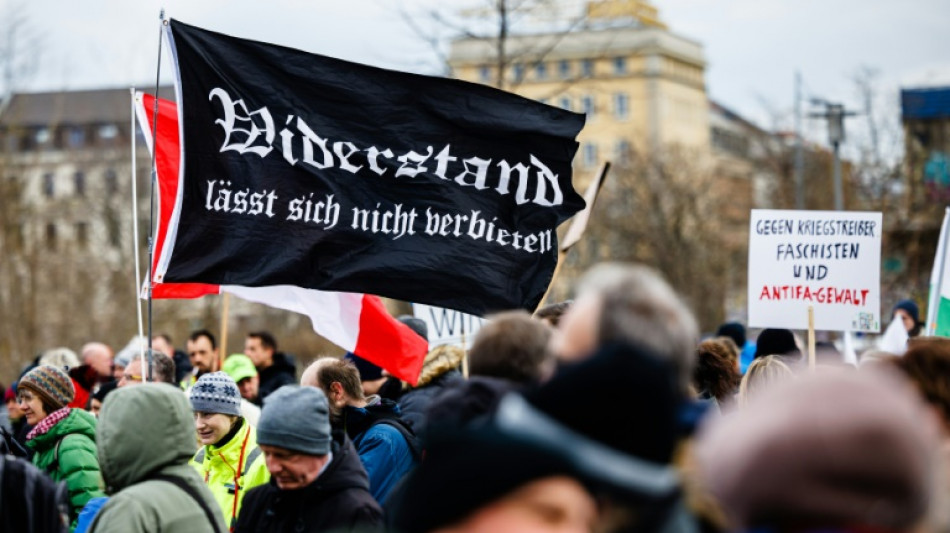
xmin=156 ymin=20 xmax=584 ymax=315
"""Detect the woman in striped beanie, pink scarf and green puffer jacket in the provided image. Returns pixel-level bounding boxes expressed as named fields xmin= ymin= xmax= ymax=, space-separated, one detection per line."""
xmin=17 ymin=365 xmax=105 ymax=531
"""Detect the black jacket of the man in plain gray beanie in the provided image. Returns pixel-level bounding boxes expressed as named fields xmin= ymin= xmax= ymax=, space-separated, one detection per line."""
xmin=235 ymin=431 xmax=383 ymax=533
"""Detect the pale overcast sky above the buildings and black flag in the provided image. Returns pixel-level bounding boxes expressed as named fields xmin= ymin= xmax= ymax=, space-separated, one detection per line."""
xmin=0 ymin=0 xmax=950 ymax=137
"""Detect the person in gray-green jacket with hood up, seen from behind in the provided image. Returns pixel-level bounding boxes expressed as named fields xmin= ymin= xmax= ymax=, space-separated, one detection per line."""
xmin=89 ymin=383 xmax=227 ymax=533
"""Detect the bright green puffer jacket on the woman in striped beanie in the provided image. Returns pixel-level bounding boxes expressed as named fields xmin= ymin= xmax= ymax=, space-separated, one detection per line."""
xmin=26 ymin=409 xmax=105 ymax=530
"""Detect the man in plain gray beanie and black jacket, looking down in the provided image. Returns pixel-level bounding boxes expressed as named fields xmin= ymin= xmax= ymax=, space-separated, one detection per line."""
xmin=235 ymin=385 xmax=382 ymax=533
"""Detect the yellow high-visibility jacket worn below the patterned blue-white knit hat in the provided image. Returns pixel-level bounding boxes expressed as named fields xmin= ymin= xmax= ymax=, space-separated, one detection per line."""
xmin=190 ymin=418 xmax=270 ymax=531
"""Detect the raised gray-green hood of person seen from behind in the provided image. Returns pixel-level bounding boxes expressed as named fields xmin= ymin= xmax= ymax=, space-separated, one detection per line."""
xmin=96 ymin=383 xmax=198 ymax=493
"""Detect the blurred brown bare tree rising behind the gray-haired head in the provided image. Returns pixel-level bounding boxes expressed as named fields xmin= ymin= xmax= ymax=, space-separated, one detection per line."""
xmin=556 ymin=146 xmax=743 ymax=329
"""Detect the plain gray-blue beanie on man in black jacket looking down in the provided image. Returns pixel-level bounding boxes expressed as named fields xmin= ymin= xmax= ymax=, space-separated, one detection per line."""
xmin=257 ymin=385 xmax=330 ymax=455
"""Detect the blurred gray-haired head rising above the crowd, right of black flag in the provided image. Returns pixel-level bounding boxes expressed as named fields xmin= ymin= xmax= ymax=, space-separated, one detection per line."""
xmin=552 ymin=263 xmax=699 ymax=391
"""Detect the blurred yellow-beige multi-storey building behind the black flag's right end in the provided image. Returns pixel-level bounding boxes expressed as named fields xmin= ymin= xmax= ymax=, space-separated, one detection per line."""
xmin=449 ymin=0 xmax=709 ymax=181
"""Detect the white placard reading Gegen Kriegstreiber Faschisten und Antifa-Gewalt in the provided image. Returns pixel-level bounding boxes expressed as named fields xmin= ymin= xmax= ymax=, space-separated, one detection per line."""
xmin=749 ymin=209 xmax=882 ymax=332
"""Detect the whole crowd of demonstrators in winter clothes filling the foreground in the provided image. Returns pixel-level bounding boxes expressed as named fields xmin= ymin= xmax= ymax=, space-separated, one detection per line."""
xmin=0 ymin=264 xmax=950 ymax=533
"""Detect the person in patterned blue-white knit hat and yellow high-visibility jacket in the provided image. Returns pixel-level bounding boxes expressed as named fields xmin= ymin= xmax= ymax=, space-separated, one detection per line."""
xmin=190 ymin=372 xmax=270 ymax=531
